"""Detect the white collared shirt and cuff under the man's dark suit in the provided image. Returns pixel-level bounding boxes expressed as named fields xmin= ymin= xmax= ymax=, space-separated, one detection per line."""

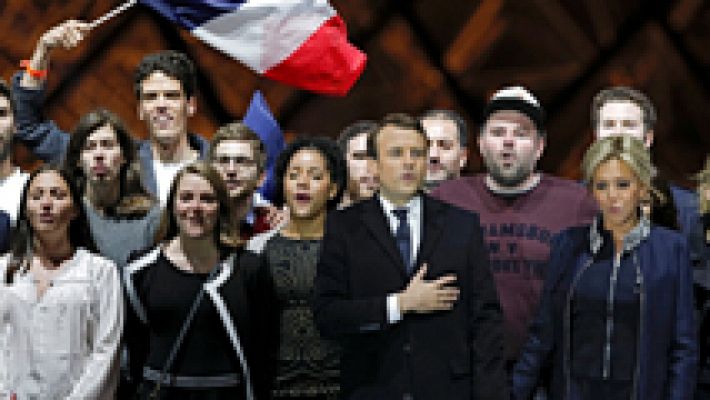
xmin=377 ymin=193 xmax=423 ymax=324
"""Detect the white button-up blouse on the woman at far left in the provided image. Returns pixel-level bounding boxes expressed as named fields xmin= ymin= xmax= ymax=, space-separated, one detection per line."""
xmin=0 ymin=248 xmax=123 ymax=400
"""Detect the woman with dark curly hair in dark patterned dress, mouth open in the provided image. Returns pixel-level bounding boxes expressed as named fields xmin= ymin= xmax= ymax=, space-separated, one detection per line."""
xmin=249 ymin=138 xmax=346 ymax=400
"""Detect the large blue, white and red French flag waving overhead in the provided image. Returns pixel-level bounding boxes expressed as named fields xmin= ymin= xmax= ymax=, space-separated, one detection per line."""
xmin=140 ymin=0 xmax=367 ymax=96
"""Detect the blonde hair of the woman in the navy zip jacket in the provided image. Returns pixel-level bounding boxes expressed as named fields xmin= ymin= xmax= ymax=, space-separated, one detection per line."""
xmin=582 ymin=135 xmax=665 ymax=195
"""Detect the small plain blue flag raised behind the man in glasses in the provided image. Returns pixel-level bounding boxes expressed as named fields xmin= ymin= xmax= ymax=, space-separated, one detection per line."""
xmin=243 ymin=90 xmax=285 ymax=201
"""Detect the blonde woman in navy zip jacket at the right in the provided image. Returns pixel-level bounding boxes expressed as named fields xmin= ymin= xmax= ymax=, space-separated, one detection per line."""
xmin=513 ymin=137 xmax=697 ymax=400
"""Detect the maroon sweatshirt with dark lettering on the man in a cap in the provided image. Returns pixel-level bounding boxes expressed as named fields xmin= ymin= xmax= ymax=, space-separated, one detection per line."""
xmin=432 ymin=174 xmax=597 ymax=361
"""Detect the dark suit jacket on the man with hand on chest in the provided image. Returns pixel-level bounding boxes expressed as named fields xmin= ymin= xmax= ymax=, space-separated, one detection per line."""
xmin=314 ymin=195 xmax=508 ymax=400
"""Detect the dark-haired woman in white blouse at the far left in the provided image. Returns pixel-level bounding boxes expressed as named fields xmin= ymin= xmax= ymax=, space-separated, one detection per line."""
xmin=0 ymin=167 xmax=123 ymax=400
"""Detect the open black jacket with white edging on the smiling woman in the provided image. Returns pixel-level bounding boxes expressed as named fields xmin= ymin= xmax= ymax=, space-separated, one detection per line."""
xmin=124 ymin=247 xmax=278 ymax=400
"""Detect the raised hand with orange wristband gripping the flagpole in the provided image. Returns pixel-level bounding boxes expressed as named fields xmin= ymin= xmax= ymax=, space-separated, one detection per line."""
xmin=21 ymin=19 xmax=90 ymax=88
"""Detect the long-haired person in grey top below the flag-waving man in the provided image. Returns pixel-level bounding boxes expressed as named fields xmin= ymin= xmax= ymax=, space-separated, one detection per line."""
xmin=63 ymin=109 xmax=160 ymax=268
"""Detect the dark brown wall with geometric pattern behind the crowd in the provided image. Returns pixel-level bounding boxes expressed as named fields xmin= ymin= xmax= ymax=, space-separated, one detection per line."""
xmin=0 ymin=0 xmax=710 ymax=185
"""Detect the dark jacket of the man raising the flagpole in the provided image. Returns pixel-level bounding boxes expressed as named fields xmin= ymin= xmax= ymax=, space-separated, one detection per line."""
xmin=12 ymin=73 xmax=209 ymax=196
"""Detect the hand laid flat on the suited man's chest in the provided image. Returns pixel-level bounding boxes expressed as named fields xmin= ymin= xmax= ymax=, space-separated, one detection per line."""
xmin=397 ymin=263 xmax=459 ymax=315
